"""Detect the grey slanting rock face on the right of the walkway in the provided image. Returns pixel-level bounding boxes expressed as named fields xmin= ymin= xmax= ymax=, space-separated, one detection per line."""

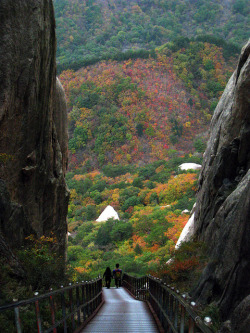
xmin=194 ymin=42 xmax=250 ymax=326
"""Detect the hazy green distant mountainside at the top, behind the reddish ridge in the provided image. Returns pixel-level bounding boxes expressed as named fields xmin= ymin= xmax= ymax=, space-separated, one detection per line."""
xmin=54 ymin=0 xmax=250 ymax=71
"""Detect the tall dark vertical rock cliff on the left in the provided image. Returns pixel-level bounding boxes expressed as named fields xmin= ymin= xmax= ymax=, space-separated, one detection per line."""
xmin=0 ymin=0 xmax=68 ymax=253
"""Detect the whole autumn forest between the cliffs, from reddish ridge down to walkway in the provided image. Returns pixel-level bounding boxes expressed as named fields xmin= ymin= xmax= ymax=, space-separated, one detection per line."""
xmin=60 ymin=37 xmax=236 ymax=300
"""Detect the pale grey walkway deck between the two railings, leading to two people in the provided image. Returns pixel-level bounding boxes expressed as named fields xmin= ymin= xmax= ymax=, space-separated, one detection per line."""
xmin=81 ymin=288 xmax=159 ymax=333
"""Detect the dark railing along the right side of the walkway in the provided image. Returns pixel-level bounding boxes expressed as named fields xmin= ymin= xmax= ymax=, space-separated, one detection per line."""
xmin=122 ymin=273 xmax=212 ymax=333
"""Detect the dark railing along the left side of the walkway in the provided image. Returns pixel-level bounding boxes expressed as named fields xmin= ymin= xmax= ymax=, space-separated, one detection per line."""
xmin=0 ymin=278 xmax=103 ymax=333
